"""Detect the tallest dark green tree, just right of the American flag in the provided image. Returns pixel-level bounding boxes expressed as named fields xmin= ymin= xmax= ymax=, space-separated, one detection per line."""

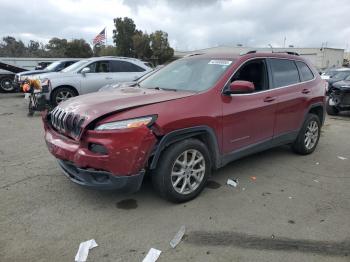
xmin=113 ymin=17 xmax=136 ymax=57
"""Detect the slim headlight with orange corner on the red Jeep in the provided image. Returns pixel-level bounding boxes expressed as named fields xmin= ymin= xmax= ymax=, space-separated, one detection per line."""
xmin=95 ymin=116 xmax=157 ymax=131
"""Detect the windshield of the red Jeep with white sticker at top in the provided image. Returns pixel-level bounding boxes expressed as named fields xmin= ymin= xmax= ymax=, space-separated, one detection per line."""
xmin=140 ymin=58 xmax=232 ymax=92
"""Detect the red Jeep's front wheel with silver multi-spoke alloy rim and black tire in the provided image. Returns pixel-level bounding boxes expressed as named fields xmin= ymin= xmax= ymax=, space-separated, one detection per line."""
xmin=152 ymin=139 xmax=211 ymax=203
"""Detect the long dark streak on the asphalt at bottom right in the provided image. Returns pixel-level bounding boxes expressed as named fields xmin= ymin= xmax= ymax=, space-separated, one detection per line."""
xmin=185 ymin=231 xmax=350 ymax=256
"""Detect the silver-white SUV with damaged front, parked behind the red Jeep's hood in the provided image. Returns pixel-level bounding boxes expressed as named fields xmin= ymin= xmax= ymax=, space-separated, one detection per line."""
xmin=38 ymin=57 xmax=152 ymax=106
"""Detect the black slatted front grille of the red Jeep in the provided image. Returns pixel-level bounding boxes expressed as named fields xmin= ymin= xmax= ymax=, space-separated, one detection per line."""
xmin=50 ymin=107 xmax=85 ymax=137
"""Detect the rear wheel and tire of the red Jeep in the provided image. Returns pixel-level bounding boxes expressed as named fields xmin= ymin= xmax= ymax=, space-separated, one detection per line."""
xmin=292 ymin=114 xmax=321 ymax=155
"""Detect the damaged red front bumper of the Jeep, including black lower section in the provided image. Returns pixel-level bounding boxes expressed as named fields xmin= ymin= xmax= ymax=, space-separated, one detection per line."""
xmin=43 ymin=116 xmax=157 ymax=192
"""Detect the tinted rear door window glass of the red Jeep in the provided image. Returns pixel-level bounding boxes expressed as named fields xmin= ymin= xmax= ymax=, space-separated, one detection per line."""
xmin=269 ymin=58 xmax=300 ymax=88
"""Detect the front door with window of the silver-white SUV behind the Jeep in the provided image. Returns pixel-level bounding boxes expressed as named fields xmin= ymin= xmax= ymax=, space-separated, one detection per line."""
xmin=79 ymin=60 xmax=113 ymax=94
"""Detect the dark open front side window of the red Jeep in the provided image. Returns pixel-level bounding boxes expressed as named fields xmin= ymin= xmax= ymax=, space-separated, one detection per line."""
xmin=231 ymin=59 xmax=269 ymax=92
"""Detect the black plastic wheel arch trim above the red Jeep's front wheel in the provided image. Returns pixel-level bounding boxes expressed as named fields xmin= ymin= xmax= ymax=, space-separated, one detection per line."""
xmin=150 ymin=126 xmax=221 ymax=169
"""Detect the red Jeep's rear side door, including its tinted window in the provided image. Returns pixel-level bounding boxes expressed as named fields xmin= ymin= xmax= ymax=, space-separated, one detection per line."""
xmin=267 ymin=58 xmax=309 ymax=138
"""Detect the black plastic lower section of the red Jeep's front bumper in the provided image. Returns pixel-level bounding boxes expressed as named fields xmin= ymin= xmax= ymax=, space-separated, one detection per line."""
xmin=57 ymin=160 xmax=145 ymax=192
